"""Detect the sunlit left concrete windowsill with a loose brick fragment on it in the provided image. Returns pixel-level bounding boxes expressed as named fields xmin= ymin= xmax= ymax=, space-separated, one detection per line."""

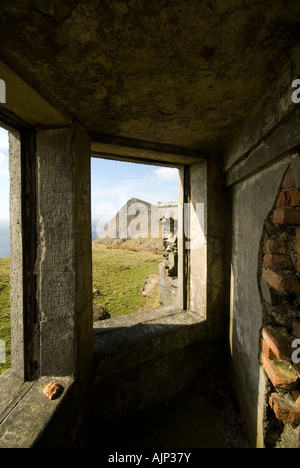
xmin=0 ymin=369 xmax=74 ymax=448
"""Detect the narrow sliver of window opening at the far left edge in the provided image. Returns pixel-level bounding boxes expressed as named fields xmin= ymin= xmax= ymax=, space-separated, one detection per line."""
xmin=0 ymin=127 xmax=11 ymax=375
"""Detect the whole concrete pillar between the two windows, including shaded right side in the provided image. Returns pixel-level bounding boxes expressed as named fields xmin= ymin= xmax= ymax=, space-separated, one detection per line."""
xmin=36 ymin=125 xmax=92 ymax=375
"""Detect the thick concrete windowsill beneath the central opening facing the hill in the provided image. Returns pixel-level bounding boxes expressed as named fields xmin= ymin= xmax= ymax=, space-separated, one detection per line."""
xmin=94 ymin=307 xmax=207 ymax=372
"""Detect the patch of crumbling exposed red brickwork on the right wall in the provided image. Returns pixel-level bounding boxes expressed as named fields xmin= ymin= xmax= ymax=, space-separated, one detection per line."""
xmin=260 ymin=157 xmax=300 ymax=448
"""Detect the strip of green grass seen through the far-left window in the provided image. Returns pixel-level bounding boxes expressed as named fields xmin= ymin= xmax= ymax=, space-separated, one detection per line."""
xmin=0 ymin=258 xmax=11 ymax=375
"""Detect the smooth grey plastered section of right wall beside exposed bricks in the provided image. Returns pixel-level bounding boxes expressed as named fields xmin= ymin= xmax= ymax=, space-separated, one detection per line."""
xmin=230 ymin=156 xmax=289 ymax=446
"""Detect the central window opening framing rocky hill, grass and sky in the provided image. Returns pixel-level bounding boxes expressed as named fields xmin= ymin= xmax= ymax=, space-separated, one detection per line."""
xmin=91 ymin=158 xmax=178 ymax=322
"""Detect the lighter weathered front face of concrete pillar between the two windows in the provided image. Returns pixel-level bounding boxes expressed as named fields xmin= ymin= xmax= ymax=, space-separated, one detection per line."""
xmin=36 ymin=129 xmax=76 ymax=375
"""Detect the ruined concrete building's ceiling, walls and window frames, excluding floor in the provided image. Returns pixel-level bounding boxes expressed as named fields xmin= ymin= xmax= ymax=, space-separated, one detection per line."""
xmin=0 ymin=0 xmax=300 ymax=448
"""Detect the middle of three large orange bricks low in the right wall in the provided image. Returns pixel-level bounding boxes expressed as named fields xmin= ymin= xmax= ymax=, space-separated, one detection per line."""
xmin=261 ymin=354 xmax=299 ymax=390
